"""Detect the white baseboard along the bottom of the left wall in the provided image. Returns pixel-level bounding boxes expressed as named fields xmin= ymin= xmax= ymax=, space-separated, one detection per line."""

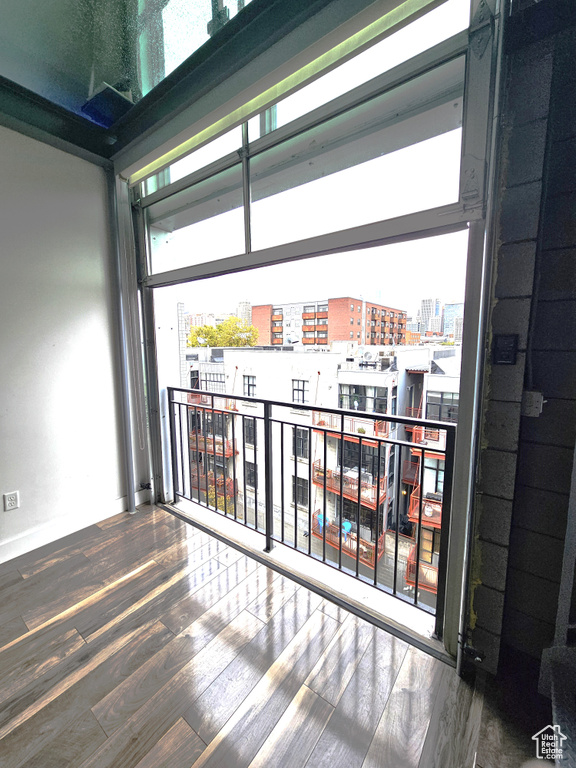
xmin=0 ymin=490 xmax=150 ymax=563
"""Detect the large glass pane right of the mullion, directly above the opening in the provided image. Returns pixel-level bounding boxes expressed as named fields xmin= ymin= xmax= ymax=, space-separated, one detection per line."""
xmin=250 ymin=58 xmax=464 ymax=250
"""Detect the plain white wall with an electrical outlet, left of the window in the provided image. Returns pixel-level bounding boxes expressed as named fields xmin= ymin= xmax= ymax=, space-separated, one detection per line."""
xmin=0 ymin=127 xmax=125 ymax=561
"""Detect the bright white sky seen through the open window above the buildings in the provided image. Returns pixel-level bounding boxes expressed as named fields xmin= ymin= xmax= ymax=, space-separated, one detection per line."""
xmin=155 ymin=231 xmax=468 ymax=322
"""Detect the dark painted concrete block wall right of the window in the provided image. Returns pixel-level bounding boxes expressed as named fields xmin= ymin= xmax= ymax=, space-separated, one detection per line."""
xmin=468 ymin=7 xmax=576 ymax=673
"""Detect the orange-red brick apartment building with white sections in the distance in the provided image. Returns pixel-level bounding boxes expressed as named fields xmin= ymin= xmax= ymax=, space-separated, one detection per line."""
xmin=252 ymin=296 xmax=406 ymax=348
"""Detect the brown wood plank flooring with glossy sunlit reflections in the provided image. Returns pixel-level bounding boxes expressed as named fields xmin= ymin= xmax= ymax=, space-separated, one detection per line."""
xmin=0 ymin=506 xmax=539 ymax=768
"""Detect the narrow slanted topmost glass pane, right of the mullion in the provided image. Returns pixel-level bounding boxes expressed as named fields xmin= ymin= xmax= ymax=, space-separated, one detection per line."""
xmin=248 ymin=0 xmax=470 ymax=141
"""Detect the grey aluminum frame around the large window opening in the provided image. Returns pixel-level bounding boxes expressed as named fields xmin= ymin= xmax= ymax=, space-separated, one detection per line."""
xmin=130 ymin=0 xmax=503 ymax=656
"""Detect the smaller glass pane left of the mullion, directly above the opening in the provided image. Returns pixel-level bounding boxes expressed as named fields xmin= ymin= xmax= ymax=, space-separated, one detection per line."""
xmin=148 ymin=165 xmax=245 ymax=273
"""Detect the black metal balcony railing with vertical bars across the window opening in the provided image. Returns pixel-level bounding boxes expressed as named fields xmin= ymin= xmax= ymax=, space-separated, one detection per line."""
xmin=168 ymin=388 xmax=456 ymax=635
